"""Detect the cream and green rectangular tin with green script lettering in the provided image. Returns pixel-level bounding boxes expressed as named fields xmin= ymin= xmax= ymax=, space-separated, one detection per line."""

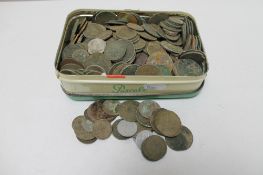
xmin=55 ymin=9 xmax=208 ymax=100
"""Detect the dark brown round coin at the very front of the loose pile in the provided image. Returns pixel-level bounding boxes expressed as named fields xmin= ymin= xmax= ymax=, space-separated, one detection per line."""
xmin=141 ymin=135 xmax=167 ymax=161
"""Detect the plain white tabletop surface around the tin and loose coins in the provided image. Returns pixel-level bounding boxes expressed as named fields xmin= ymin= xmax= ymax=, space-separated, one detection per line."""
xmin=0 ymin=0 xmax=263 ymax=175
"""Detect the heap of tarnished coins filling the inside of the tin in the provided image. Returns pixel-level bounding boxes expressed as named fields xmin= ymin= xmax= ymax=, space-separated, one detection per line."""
xmin=59 ymin=11 xmax=206 ymax=76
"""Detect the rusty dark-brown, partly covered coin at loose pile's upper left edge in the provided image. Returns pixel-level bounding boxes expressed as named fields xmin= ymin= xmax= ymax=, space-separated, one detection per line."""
xmin=84 ymin=100 xmax=116 ymax=122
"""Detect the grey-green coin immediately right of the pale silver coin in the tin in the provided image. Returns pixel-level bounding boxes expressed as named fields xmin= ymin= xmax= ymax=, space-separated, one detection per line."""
xmin=104 ymin=40 xmax=128 ymax=60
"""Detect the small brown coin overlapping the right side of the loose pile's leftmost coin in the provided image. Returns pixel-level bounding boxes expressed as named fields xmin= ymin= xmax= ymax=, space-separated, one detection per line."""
xmin=93 ymin=119 xmax=112 ymax=139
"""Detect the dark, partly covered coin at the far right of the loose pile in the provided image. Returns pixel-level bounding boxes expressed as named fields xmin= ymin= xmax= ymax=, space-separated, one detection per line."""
xmin=165 ymin=126 xmax=193 ymax=151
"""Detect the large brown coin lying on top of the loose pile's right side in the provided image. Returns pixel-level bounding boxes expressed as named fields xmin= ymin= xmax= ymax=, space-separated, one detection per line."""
xmin=153 ymin=108 xmax=182 ymax=137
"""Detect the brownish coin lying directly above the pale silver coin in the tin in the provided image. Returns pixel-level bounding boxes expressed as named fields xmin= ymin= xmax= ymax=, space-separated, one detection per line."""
xmin=83 ymin=22 xmax=106 ymax=38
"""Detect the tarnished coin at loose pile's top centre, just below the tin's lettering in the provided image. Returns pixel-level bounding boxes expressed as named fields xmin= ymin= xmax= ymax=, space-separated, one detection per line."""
xmin=116 ymin=100 xmax=140 ymax=122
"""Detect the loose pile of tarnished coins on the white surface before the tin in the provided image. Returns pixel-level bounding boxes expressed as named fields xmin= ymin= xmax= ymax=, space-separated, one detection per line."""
xmin=72 ymin=100 xmax=193 ymax=161
